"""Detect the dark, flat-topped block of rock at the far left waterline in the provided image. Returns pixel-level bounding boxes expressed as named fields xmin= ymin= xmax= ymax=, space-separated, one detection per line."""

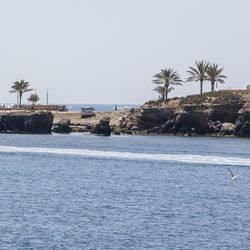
xmin=0 ymin=112 xmax=54 ymax=134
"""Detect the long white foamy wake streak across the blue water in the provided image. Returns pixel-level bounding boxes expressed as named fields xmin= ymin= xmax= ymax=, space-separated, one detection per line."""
xmin=0 ymin=146 xmax=250 ymax=166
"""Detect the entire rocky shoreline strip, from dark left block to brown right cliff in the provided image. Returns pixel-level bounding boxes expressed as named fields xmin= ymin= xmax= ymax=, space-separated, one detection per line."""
xmin=0 ymin=92 xmax=250 ymax=137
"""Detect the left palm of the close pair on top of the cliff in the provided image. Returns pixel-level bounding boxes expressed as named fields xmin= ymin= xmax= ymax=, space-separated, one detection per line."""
xmin=186 ymin=60 xmax=210 ymax=94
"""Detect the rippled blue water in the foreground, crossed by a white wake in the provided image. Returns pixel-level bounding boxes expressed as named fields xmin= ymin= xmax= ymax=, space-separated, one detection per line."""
xmin=0 ymin=133 xmax=250 ymax=249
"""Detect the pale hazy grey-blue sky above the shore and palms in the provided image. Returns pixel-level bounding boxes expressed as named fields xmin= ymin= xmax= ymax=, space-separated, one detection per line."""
xmin=0 ymin=0 xmax=250 ymax=104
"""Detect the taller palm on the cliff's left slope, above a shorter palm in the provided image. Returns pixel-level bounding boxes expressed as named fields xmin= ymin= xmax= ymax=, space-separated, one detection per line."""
xmin=153 ymin=68 xmax=182 ymax=100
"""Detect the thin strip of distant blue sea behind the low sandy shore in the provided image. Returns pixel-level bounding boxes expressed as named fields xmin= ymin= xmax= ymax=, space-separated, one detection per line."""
xmin=66 ymin=104 xmax=141 ymax=112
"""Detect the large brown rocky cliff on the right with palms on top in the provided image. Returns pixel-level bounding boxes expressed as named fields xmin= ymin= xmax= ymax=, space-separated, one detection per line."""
xmin=114 ymin=92 xmax=250 ymax=137
